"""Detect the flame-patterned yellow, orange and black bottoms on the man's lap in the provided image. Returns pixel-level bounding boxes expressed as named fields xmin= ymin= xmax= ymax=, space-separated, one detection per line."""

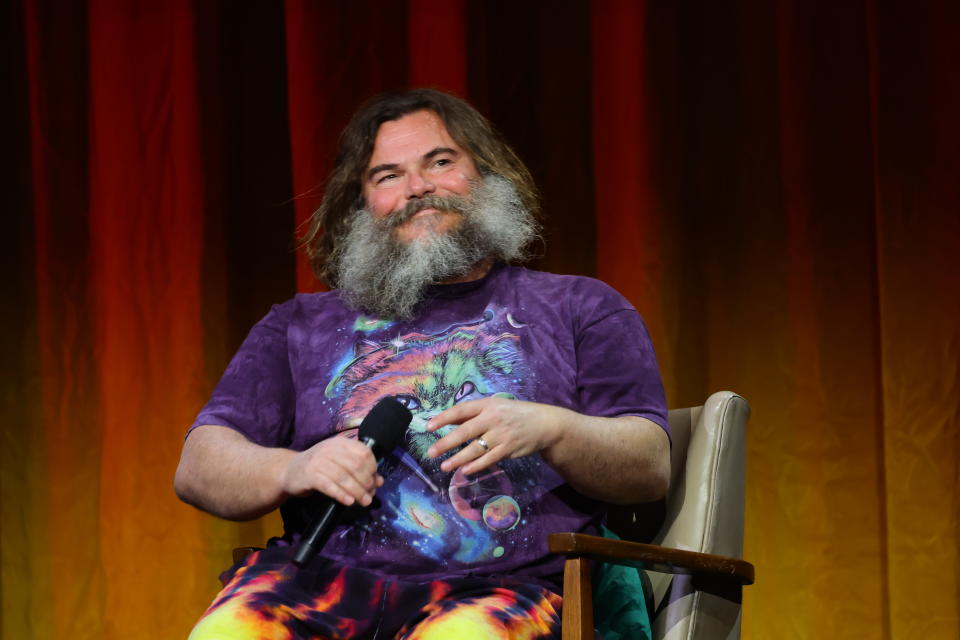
xmin=190 ymin=547 xmax=562 ymax=640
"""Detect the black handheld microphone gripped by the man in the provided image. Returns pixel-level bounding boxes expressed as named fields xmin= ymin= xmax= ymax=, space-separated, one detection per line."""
xmin=293 ymin=398 xmax=413 ymax=567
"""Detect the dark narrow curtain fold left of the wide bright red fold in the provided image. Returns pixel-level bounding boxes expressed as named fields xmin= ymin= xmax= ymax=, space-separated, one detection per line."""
xmin=19 ymin=5 xmax=104 ymax=637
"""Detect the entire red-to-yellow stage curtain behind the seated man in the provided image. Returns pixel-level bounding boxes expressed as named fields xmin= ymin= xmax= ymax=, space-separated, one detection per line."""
xmin=0 ymin=0 xmax=960 ymax=638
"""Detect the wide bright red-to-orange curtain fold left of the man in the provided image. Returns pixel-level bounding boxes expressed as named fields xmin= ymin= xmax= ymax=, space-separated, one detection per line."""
xmin=84 ymin=0 xmax=205 ymax=637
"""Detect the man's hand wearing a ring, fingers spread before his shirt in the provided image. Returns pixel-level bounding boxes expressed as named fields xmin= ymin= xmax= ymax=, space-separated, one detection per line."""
xmin=427 ymin=397 xmax=570 ymax=475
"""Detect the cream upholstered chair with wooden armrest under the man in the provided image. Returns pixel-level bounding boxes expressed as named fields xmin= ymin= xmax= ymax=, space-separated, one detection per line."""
xmin=548 ymin=391 xmax=754 ymax=640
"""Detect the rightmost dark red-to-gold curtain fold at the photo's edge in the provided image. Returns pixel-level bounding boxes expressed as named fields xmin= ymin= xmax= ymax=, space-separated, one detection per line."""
xmin=869 ymin=3 xmax=960 ymax=638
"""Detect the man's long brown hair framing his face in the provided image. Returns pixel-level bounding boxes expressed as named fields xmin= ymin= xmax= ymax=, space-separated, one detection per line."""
xmin=300 ymin=89 xmax=540 ymax=287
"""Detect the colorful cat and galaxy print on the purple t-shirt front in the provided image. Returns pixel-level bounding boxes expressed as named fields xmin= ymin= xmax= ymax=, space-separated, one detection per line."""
xmin=326 ymin=310 xmax=542 ymax=563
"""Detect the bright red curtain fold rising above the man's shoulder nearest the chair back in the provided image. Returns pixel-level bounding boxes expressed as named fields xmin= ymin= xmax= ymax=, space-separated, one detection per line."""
xmin=591 ymin=0 xmax=672 ymax=368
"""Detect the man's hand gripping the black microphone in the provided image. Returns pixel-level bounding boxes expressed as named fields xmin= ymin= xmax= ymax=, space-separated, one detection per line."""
xmin=280 ymin=436 xmax=383 ymax=507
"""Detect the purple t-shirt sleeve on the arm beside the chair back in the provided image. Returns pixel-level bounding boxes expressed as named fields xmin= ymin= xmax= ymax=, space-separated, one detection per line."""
xmin=576 ymin=289 xmax=670 ymax=435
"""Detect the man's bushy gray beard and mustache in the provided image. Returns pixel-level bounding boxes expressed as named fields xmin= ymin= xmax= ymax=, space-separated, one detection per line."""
xmin=334 ymin=175 xmax=539 ymax=319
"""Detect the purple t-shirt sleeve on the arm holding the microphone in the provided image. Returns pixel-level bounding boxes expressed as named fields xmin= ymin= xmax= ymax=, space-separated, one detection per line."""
xmin=188 ymin=303 xmax=295 ymax=447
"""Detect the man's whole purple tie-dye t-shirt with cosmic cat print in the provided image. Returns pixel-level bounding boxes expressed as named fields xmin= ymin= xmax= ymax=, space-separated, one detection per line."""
xmin=194 ymin=265 xmax=667 ymax=579
